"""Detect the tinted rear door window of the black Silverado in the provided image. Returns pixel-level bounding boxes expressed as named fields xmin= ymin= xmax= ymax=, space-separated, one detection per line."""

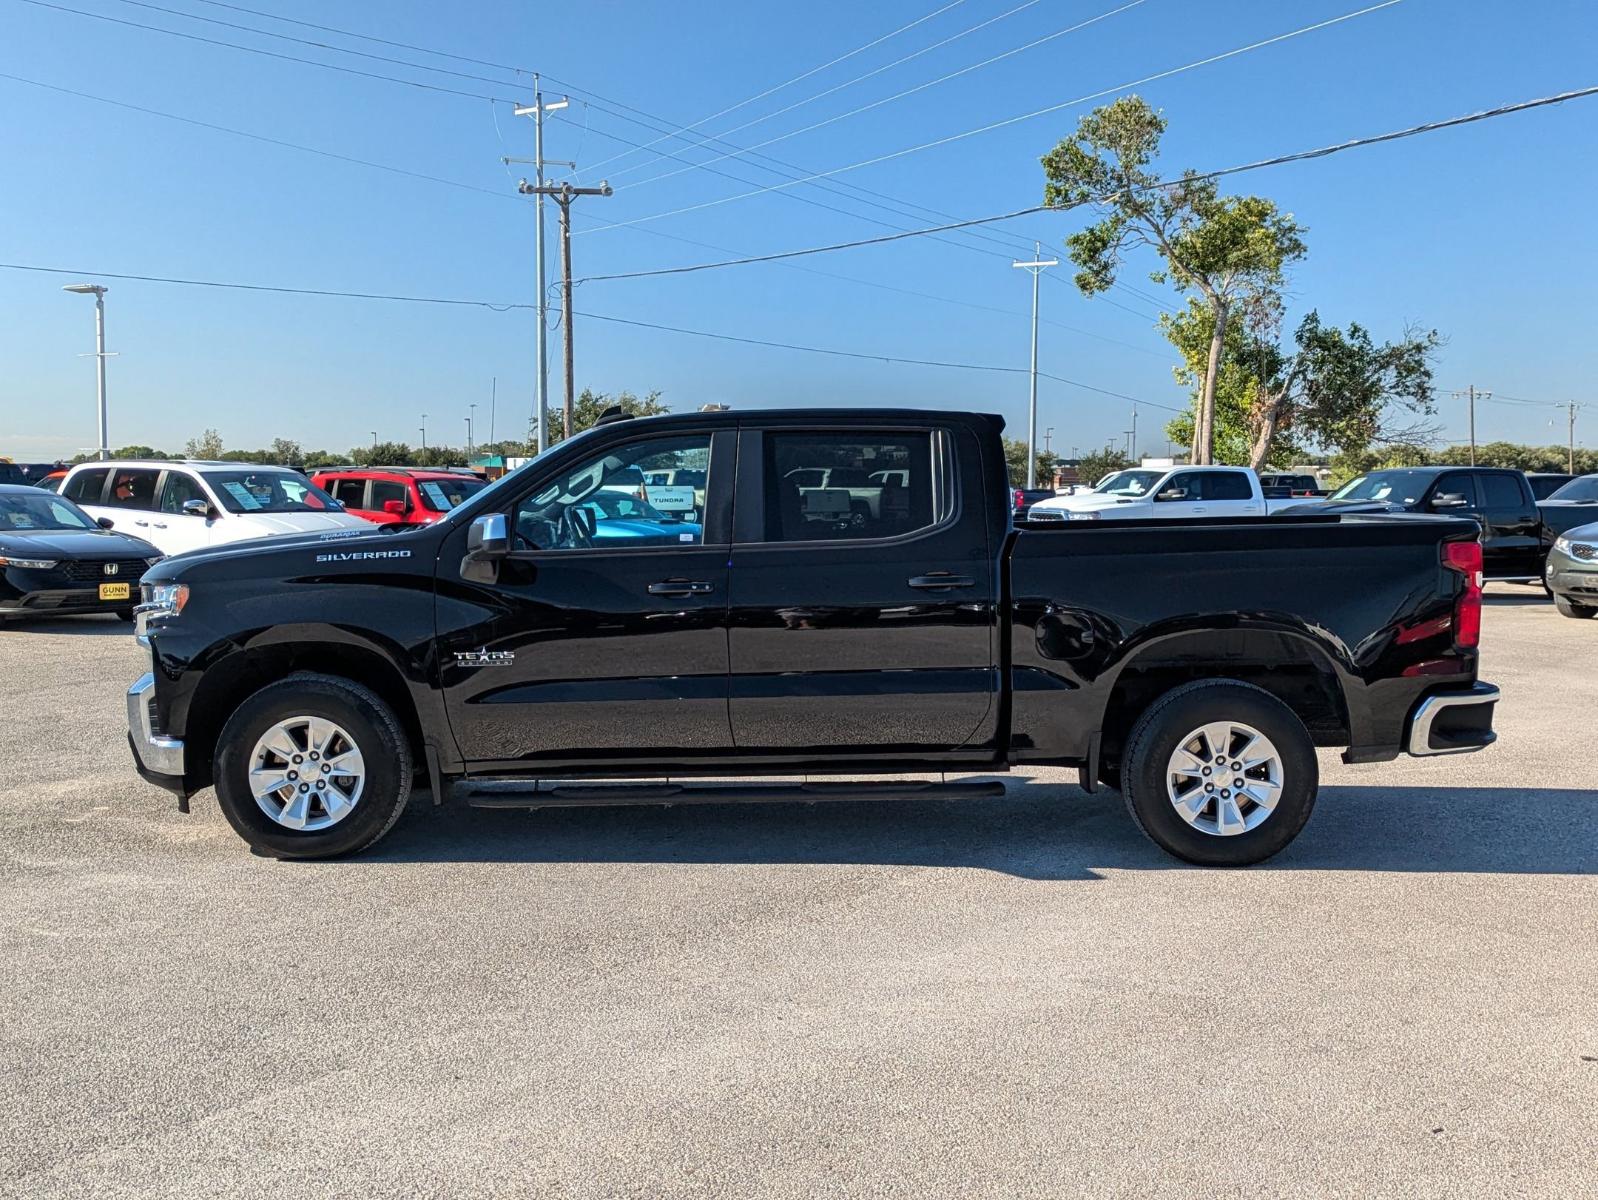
xmin=765 ymin=431 xmax=936 ymax=542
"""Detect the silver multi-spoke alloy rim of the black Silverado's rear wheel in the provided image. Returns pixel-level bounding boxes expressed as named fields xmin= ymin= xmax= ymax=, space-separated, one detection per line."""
xmin=1165 ymin=721 xmax=1282 ymax=837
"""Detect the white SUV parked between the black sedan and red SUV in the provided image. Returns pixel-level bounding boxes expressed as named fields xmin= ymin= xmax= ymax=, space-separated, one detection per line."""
xmin=61 ymin=459 xmax=368 ymax=554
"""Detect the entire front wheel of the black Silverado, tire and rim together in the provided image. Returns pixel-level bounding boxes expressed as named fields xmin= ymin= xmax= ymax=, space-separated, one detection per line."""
xmin=216 ymin=674 xmax=412 ymax=858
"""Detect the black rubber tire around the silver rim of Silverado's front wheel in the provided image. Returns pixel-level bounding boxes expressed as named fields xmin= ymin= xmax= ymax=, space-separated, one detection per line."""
xmin=216 ymin=673 xmax=414 ymax=858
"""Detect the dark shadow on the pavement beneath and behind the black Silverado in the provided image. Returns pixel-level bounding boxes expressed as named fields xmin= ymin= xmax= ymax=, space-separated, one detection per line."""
xmin=362 ymin=781 xmax=1598 ymax=880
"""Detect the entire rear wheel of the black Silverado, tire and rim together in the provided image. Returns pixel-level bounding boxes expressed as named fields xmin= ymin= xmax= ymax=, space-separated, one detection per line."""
xmin=1122 ymin=679 xmax=1320 ymax=866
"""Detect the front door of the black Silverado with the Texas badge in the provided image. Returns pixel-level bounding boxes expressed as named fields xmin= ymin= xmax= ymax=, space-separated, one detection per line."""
xmin=438 ymin=431 xmax=737 ymax=773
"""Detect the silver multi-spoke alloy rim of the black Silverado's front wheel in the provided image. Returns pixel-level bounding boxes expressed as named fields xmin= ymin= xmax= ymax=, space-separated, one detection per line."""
xmin=249 ymin=717 xmax=366 ymax=832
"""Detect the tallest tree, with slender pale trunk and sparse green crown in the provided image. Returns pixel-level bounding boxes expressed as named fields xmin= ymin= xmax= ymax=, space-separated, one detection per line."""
xmin=1042 ymin=96 xmax=1304 ymax=463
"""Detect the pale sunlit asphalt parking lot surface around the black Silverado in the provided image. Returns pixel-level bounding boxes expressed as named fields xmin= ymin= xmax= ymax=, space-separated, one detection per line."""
xmin=0 ymin=586 xmax=1598 ymax=1197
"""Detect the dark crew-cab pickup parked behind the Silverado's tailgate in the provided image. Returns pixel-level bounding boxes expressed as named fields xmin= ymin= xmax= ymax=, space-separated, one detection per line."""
xmin=1325 ymin=467 xmax=1592 ymax=583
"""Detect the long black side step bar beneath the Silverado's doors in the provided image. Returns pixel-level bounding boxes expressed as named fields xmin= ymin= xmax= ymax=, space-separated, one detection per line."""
xmin=462 ymin=781 xmax=1004 ymax=809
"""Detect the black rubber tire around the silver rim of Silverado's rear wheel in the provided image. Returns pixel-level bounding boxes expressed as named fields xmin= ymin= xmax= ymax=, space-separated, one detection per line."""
xmin=1122 ymin=679 xmax=1320 ymax=866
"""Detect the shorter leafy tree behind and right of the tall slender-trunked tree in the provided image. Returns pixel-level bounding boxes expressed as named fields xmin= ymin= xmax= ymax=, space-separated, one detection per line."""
xmin=1160 ymin=300 xmax=1441 ymax=470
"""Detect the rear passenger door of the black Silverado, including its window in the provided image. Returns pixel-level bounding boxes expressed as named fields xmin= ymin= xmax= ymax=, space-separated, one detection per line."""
xmin=729 ymin=430 xmax=997 ymax=757
